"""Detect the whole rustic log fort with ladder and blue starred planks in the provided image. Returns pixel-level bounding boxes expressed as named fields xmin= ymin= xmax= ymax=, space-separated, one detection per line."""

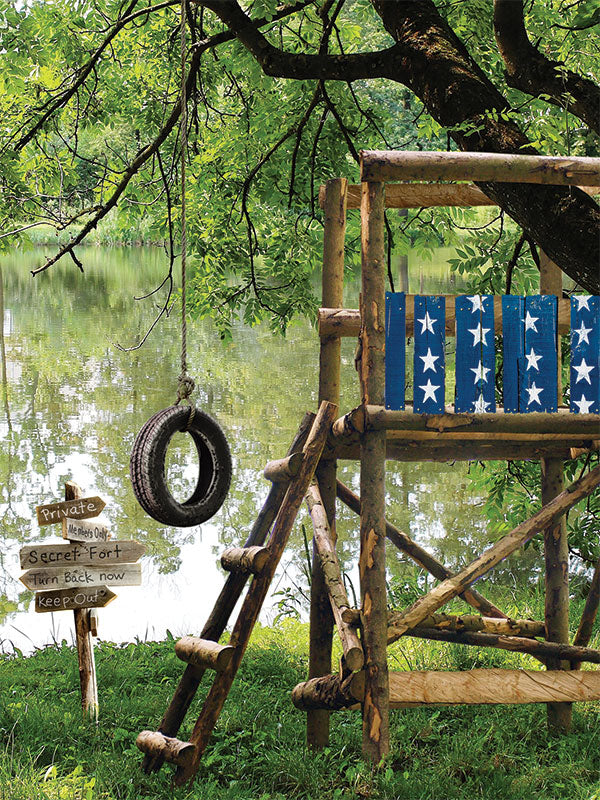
xmin=138 ymin=151 xmax=600 ymax=783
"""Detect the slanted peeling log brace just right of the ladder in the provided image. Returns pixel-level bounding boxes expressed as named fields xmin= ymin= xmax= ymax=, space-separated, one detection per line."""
xmin=306 ymin=481 xmax=365 ymax=671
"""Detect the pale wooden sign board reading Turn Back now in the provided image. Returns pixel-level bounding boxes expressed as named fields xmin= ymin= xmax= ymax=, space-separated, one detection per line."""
xmin=21 ymin=564 xmax=142 ymax=592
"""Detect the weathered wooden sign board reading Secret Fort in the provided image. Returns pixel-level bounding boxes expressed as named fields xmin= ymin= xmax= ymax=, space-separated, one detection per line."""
xmin=19 ymin=540 xmax=146 ymax=569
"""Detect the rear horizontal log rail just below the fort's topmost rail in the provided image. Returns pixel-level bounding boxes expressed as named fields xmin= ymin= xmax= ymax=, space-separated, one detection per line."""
xmin=319 ymin=183 xmax=600 ymax=210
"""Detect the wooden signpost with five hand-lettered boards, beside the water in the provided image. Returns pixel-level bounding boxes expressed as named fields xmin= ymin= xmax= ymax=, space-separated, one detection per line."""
xmin=19 ymin=481 xmax=146 ymax=722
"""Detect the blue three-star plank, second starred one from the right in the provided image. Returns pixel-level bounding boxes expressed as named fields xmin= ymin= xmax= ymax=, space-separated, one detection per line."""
xmin=519 ymin=295 xmax=558 ymax=414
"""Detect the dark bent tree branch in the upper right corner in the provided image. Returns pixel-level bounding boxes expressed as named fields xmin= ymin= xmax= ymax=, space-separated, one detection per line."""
xmin=494 ymin=0 xmax=600 ymax=135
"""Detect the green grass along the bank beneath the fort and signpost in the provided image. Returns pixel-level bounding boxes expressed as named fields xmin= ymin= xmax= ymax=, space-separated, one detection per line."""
xmin=0 ymin=621 xmax=600 ymax=800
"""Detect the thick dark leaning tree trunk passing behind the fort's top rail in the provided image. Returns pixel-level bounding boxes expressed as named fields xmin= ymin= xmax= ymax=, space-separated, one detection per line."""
xmin=372 ymin=0 xmax=600 ymax=294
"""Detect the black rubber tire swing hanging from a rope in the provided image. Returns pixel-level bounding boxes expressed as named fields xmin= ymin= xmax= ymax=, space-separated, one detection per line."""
xmin=130 ymin=406 xmax=232 ymax=528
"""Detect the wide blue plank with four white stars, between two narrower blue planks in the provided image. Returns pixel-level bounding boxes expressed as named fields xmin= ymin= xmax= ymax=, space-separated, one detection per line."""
xmin=454 ymin=295 xmax=496 ymax=413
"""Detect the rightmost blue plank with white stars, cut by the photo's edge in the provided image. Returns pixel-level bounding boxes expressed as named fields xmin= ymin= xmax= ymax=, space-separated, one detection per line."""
xmin=571 ymin=295 xmax=600 ymax=414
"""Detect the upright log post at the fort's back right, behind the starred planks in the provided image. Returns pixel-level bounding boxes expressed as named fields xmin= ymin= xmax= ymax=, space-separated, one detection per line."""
xmin=540 ymin=252 xmax=572 ymax=733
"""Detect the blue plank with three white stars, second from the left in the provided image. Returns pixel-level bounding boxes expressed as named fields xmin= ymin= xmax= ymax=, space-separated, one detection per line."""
xmin=413 ymin=295 xmax=446 ymax=414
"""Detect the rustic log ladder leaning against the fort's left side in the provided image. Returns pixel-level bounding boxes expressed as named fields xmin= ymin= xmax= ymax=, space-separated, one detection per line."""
xmin=137 ymin=402 xmax=337 ymax=785
